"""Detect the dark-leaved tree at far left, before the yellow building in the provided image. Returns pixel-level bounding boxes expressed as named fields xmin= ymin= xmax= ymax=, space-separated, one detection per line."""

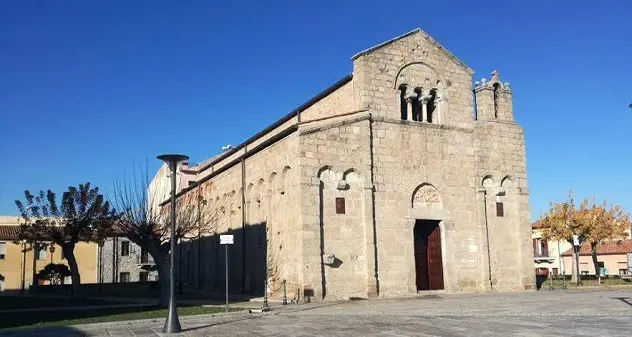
xmin=15 ymin=183 xmax=116 ymax=294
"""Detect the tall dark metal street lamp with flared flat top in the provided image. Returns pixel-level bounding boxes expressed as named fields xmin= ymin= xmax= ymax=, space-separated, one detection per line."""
xmin=157 ymin=154 xmax=189 ymax=333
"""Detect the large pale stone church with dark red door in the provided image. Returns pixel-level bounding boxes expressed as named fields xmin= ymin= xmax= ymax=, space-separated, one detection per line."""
xmin=157 ymin=29 xmax=535 ymax=300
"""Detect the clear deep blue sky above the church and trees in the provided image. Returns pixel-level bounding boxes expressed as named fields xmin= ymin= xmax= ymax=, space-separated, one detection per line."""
xmin=0 ymin=0 xmax=632 ymax=218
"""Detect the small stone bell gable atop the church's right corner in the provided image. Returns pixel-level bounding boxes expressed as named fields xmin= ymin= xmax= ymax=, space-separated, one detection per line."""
xmin=474 ymin=70 xmax=513 ymax=121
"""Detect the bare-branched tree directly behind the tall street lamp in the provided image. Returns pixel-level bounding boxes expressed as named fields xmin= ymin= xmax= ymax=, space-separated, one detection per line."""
xmin=113 ymin=163 xmax=223 ymax=305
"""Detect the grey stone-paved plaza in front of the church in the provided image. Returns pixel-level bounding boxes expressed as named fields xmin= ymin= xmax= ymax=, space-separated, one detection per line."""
xmin=0 ymin=290 xmax=632 ymax=337
